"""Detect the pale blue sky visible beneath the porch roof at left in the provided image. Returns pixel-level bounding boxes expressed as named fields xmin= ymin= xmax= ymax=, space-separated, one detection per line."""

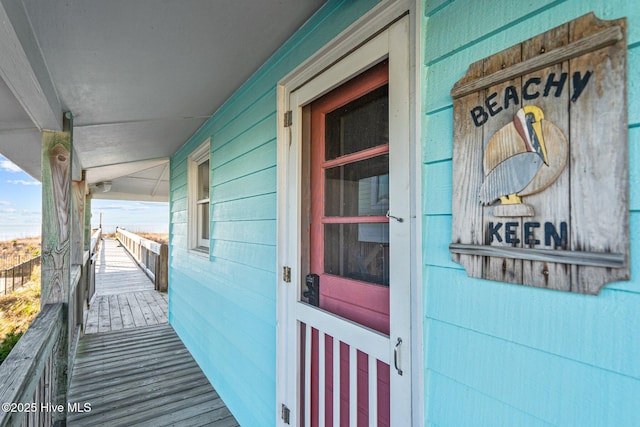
xmin=0 ymin=154 xmax=169 ymax=240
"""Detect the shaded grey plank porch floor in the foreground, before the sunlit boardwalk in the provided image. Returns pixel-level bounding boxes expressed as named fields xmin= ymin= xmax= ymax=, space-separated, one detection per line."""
xmin=67 ymin=324 xmax=238 ymax=427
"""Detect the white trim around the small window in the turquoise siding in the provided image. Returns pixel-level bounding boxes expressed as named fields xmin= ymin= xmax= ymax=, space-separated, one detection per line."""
xmin=187 ymin=138 xmax=211 ymax=255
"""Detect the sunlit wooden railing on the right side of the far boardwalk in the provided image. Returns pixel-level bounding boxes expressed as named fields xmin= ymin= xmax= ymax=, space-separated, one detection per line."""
xmin=116 ymin=228 xmax=169 ymax=292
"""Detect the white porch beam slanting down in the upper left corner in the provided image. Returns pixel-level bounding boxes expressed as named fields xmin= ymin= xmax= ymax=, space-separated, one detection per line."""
xmin=0 ymin=0 xmax=62 ymax=131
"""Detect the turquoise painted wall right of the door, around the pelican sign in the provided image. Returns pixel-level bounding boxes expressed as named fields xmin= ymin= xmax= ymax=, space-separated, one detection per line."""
xmin=422 ymin=0 xmax=640 ymax=427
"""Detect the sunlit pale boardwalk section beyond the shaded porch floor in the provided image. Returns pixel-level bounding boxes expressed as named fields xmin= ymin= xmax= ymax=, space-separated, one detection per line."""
xmin=84 ymin=239 xmax=168 ymax=334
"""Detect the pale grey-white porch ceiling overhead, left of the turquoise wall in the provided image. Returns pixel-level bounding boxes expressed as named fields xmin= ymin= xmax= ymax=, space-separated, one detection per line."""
xmin=0 ymin=0 xmax=324 ymax=200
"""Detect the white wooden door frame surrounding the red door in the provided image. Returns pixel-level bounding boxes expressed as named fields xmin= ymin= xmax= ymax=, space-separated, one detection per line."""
xmin=276 ymin=0 xmax=424 ymax=425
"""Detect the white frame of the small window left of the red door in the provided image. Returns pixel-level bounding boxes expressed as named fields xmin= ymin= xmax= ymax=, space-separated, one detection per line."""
xmin=187 ymin=138 xmax=211 ymax=254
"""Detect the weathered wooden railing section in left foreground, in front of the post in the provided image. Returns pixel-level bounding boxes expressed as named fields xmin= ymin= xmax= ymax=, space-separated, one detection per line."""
xmin=0 ymin=303 xmax=66 ymax=427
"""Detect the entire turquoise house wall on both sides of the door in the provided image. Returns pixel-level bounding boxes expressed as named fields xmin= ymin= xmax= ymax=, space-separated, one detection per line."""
xmin=169 ymin=0 xmax=640 ymax=426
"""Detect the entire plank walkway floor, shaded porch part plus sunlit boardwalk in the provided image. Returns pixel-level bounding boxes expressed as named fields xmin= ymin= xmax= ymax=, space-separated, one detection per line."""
xmin=67 ymin=240 xmax=239 ymax=427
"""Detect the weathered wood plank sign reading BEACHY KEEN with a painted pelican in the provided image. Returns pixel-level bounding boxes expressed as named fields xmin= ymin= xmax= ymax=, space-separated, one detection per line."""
xmin=450 ymin=14 xmax=630 ymax=294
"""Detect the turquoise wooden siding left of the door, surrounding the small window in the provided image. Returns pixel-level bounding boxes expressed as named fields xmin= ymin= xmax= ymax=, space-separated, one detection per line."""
xmin=169 ymin=0 xmax=376 ymax=426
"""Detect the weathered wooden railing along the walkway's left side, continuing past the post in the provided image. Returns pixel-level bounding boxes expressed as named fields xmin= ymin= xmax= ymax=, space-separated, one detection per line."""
xmin=0 ymin=230 xmax=101 ymax=427
